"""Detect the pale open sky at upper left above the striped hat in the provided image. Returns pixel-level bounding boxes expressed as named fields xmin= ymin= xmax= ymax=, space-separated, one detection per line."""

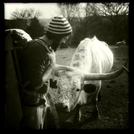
xmin=4 ymin=3 xmax=60 ymax=19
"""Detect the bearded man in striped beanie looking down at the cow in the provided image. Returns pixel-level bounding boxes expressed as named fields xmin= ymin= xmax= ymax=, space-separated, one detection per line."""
xmin=19 ymin=16 xmax=72 ymax=129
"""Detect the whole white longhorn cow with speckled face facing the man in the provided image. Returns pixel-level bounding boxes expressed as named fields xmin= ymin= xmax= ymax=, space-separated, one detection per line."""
xmin=49 ymin=37 xmax=124 ymax=124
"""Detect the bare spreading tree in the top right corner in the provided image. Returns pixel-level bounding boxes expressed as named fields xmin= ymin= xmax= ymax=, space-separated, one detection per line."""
xmin=96 ymin=3 xmax=129 ymax=42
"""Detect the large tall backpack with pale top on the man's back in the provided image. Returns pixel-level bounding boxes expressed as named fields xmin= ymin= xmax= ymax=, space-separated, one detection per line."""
xmin=5 ymin=29 xmax=32 ymax=129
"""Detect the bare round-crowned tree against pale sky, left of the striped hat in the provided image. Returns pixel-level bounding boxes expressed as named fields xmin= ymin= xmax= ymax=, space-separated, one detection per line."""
xmin=11 ymin=8 xmax=44 ymax=38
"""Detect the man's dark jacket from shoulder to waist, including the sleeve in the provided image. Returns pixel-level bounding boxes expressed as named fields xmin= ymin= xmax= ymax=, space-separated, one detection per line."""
xmin=20 ymin=40 xmax=50 ymax=93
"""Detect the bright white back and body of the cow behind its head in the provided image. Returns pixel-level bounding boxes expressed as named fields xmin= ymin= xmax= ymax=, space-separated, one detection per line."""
xmin=70 ymin=37 xmax=113 ymax=73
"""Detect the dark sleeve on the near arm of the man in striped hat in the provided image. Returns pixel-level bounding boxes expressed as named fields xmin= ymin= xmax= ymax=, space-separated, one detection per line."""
xmin=28 ymin=45 xmax=49 ymax=92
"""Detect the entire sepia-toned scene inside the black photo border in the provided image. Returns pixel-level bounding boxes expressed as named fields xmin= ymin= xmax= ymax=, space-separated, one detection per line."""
xmin=4 ymin=2 xmax=130 ymax=130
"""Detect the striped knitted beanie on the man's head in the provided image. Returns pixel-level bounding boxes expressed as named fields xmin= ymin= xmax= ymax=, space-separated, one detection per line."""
xmin=47 ymin=17 xmax=72 ymax=35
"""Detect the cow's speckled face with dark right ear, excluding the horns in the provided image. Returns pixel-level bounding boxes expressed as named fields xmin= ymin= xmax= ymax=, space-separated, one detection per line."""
xmin=57 ymin=71 xmax=96 ymax=112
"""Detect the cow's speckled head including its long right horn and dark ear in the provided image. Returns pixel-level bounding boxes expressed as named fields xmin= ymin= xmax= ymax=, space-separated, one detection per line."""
xmin=50 ymin=62 xmax=127 ymax=112
